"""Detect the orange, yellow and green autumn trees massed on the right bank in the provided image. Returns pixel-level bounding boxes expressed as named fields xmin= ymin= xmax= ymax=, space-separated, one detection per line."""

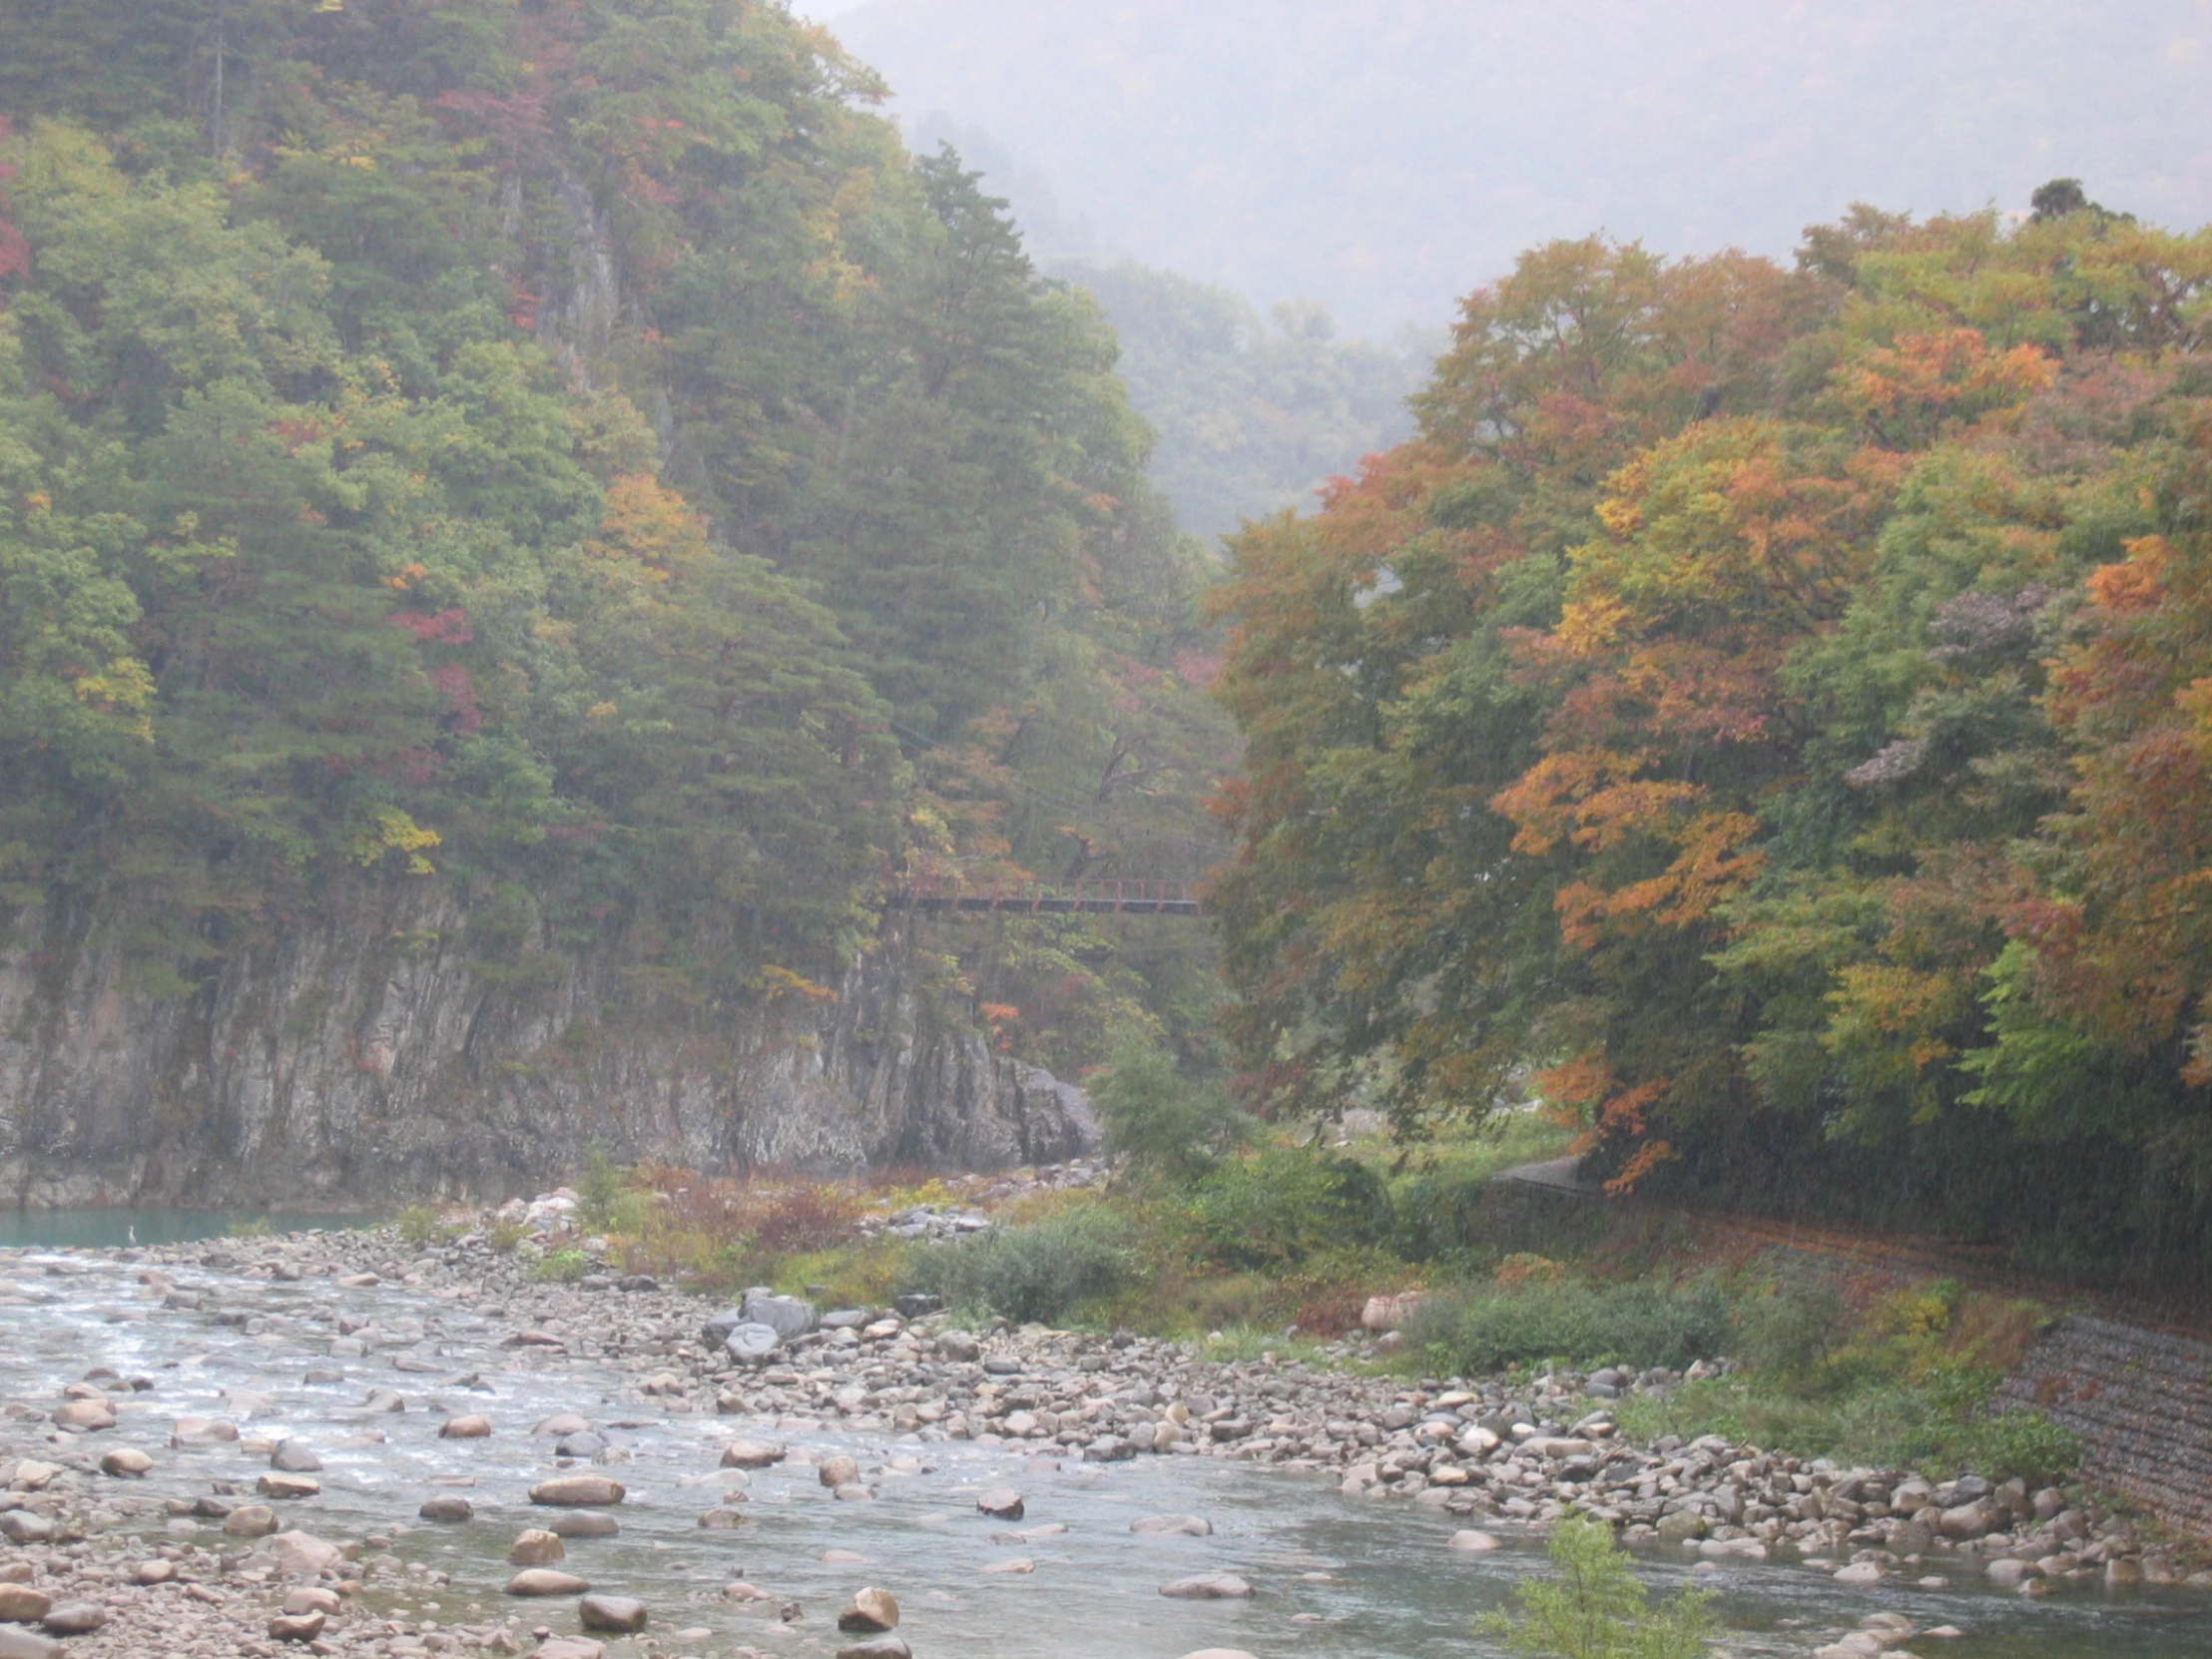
xmin=1219 ymin=201 xmax=2212 ymax=1268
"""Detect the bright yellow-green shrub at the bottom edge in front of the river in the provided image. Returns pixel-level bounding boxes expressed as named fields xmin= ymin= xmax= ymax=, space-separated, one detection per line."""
xmin=1484 ymin=1515 xmax=1717 ymax=1659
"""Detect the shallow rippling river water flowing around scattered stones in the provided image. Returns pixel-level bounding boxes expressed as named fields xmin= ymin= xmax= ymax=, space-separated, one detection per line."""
xmin=0 ymin=1250 xmax=2212 ymax=1659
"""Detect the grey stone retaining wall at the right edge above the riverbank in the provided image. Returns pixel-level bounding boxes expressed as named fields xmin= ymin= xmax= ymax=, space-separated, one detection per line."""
xmin=1997 ymin=1314 xmax=2212 ymax=1533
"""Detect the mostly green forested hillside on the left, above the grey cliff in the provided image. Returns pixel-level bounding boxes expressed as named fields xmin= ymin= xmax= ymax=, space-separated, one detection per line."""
xmin=0 ymin=0 xmax=1226 ymax=1079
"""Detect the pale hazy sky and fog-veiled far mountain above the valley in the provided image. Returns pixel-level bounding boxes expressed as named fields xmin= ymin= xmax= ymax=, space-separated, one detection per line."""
xmin=795 ymin=0 xmax=2212 ymax=331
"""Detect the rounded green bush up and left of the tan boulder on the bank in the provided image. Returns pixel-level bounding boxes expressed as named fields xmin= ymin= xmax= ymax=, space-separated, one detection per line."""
xmin=1186 ymin=1146 xmax=1391 ymax=1272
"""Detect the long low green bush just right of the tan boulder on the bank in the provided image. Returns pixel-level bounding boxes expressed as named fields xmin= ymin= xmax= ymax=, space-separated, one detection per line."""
xmin=1409 ymin=1281 xmax=1734 ymax=1374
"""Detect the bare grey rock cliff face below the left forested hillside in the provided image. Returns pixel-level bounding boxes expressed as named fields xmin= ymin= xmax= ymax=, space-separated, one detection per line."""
xmin=0 ymin=891 xmax=1097 ymax=1208
